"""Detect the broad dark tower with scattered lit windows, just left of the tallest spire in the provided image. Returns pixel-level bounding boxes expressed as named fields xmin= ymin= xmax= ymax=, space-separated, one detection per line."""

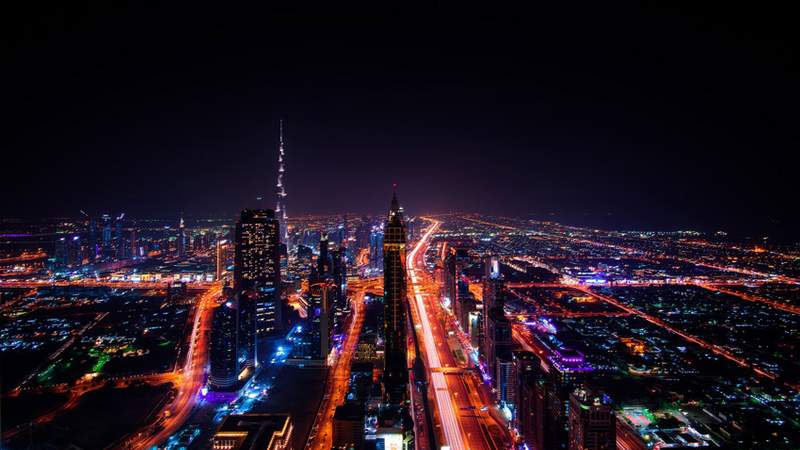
xmin=233 ymin=209 xmax=282 ymax=334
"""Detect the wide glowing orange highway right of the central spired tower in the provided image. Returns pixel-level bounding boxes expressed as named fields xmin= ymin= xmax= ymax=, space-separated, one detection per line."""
xmin=407 ymin=220 xmax=501 ymax=450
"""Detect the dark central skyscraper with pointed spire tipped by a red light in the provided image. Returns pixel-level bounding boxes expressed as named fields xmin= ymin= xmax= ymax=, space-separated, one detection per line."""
xmin=383 ymin=193 xmax=408 ymax=404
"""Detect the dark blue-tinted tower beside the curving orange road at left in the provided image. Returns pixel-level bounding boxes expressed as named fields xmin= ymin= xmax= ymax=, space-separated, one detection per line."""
xmin=208 ymin=298 xmax=240 ymax=390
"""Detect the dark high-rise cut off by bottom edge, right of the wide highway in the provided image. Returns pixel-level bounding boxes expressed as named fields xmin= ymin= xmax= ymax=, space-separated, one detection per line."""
xmin=569 ymin=389 xmax=617 ymax=450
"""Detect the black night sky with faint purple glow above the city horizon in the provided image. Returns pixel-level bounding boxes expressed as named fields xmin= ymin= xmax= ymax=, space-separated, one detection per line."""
xmin=0 ymin=2 xmax=800 ymax=239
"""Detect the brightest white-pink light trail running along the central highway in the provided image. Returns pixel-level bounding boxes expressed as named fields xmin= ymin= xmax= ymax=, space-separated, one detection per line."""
xmin=407 ymin=220 xmax=466 ymax=450
